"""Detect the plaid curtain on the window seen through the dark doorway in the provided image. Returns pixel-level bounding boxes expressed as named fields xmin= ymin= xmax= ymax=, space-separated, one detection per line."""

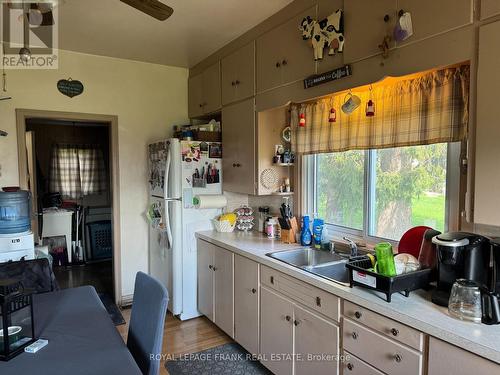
xmin=49 ymin=144 xmax=107 ymax=199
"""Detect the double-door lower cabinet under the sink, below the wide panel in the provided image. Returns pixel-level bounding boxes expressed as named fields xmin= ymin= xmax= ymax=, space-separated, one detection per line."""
xmin=260 ymin=288 xmax=339 ymax=375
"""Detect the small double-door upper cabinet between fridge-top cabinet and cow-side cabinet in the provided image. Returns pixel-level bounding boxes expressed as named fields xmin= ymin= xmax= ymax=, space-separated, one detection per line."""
xmin=222 ymin=42 xmax=255 ymax=105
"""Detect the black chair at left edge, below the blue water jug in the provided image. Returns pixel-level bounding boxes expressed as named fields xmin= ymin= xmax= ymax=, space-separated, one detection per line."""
xmin=0 ymin=258 xmax=59 ymax=293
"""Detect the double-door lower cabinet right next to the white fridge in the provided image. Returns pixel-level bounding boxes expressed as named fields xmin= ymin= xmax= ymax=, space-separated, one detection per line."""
xmin=198 ymin=240 xmax=234 ymax=337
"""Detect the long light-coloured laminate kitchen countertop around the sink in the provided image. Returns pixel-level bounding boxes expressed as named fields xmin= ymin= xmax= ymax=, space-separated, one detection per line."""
xmin=196 ymin=231 xmax=500 ymax=363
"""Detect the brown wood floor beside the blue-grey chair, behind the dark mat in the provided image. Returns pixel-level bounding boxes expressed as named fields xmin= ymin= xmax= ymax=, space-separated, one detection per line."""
xmin=116 ymin=309 xmax=233 ymax=374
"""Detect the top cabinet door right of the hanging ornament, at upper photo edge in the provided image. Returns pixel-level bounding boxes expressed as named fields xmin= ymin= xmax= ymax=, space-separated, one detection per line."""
xmin=392 ymin=0 xmax=470 ymax=45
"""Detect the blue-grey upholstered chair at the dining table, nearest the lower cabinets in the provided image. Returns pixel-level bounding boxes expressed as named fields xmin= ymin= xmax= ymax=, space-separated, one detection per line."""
xmin=127 ymin=272 xmax=168 ymax=375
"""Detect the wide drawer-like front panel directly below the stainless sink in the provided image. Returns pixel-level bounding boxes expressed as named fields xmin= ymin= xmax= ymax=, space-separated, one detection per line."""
xmin=261 ymin=266 xmax=340 ymax=322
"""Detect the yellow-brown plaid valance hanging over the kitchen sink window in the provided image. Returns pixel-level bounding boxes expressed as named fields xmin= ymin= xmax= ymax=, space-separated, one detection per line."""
xmin=290 ymin=65 xmax=469 ymax=155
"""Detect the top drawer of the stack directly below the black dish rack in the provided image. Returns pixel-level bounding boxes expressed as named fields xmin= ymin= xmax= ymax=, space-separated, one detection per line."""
xmin=344 ymin=301 xmax=424 ymax=351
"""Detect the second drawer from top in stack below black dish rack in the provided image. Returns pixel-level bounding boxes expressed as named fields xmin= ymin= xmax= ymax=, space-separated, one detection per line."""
xmin=343 ymin=318 xmax=423 ymax=375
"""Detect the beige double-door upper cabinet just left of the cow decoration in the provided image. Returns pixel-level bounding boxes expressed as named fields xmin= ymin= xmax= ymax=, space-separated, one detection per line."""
xmin=256 ymin=6 xmax=316 ymax=92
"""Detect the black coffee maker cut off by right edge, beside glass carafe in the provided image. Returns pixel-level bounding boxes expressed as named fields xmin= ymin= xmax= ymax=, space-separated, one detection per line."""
xmin=481 ymin=238 xmax=500 ymax=324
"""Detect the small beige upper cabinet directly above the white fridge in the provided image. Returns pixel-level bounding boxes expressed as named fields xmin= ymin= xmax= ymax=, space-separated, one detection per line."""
xmin=188 ymin=62 xmax=221 ymax=118
